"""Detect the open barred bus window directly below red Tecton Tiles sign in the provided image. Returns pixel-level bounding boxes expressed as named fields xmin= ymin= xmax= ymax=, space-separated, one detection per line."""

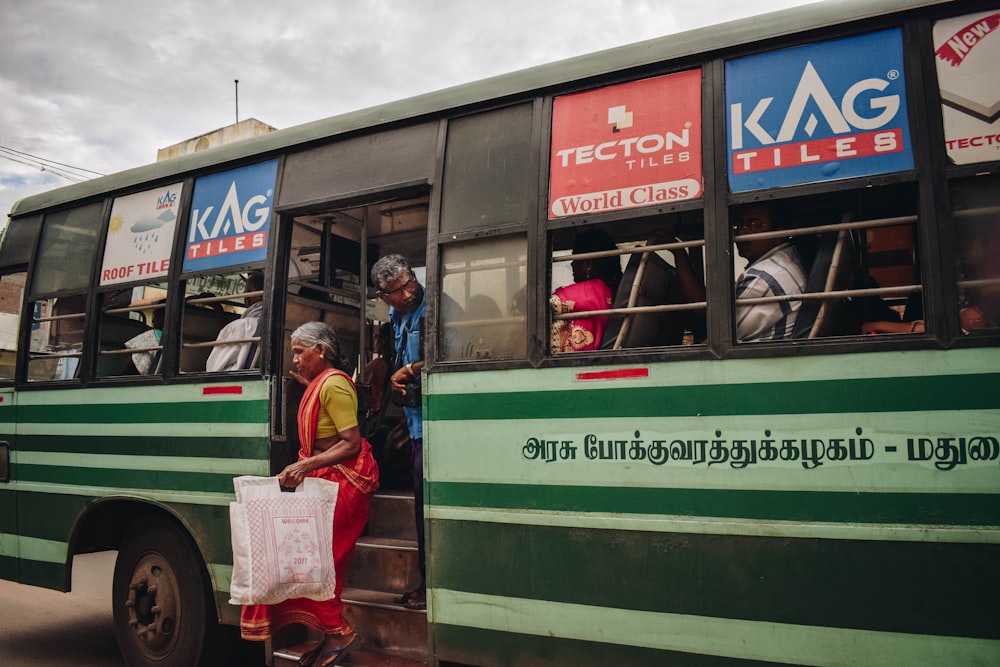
xmin=550 ymin=210 xmax=706 ymax=353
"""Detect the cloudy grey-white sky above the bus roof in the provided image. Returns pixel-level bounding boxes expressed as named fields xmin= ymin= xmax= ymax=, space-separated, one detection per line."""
xmin=0 ymin=0 xmax=812 ymax=226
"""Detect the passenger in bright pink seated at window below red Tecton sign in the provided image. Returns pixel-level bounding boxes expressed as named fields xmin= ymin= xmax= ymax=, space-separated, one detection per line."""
xmin=549 ymin=229 xmax=622 ymax=352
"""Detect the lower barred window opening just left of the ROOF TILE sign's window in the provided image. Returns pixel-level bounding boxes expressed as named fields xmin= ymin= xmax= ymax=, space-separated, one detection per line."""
xmin=28 ymin=294 xmax=87 ymax=382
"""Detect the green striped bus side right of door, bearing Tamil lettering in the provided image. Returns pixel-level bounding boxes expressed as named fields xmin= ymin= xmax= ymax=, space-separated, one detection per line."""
xmin=425 ymin=349 xmax=1000 ymax=665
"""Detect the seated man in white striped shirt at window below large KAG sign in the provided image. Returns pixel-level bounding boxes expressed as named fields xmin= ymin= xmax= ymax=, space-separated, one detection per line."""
xmin=674 ymin=204 xmax=806 ymax=342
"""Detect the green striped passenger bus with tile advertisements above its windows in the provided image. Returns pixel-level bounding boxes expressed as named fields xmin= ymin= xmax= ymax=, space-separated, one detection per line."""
xmin=0 ymin=0 xmax=1000 ymax=667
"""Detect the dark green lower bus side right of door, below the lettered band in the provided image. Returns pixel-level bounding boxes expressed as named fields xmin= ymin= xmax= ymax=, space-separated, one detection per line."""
xmin=431 ymin=521 xmax=1000 ymax=664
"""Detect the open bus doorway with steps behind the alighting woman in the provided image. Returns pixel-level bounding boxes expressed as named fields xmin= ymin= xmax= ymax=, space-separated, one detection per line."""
xmin=272 ymin=196 xmax=429 ymax=664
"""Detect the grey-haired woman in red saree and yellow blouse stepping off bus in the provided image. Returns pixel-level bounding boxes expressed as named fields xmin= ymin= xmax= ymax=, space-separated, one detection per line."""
xmin=240 ymin=322 xmax=378 ymax=667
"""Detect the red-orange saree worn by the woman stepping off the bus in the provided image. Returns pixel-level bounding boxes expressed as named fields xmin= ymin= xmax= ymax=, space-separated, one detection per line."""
xmin=240 ymin=369 xmax=378 ymax=641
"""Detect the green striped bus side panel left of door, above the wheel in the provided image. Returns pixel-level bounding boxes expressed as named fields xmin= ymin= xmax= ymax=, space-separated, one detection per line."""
xmin=4 ymin=381 xmax=269 ymax=599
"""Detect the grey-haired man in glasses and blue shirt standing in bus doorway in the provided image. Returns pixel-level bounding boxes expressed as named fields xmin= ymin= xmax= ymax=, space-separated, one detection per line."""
xmin=372 ymin=255 xmax=427 ymax=609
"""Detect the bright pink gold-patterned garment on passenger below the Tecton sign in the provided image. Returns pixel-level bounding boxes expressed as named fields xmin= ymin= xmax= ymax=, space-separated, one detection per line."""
xmin=551 ymin=278 xmax=614 ymax=352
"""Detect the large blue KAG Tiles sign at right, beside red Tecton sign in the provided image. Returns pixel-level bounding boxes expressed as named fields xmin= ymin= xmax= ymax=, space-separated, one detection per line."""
xmin=726 ymin=29 xmax=913 ymax=192
